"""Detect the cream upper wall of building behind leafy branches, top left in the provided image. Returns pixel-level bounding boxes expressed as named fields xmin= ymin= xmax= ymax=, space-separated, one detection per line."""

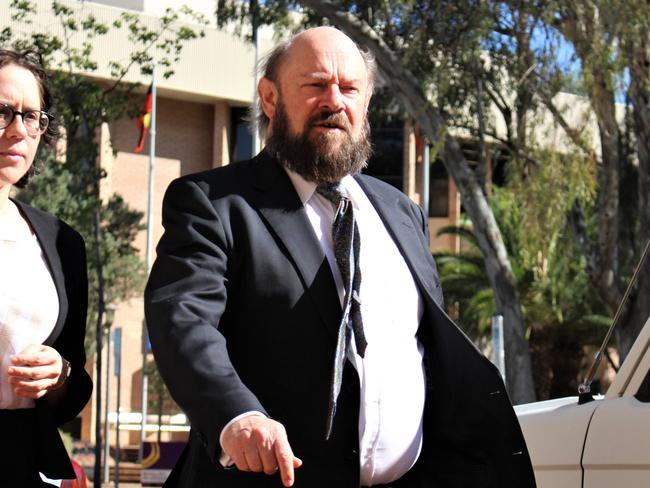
xmin=0 ymin=0 xmax=275 ymax=104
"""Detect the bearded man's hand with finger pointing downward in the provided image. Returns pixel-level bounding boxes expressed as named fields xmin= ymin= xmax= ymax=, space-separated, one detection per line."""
xmin=221 ymin=415 xmax=302 ymax=487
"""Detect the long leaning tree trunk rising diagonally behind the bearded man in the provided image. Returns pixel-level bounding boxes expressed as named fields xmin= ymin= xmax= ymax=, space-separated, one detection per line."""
xmin=301 ymin=0 xmax=535 ymax=403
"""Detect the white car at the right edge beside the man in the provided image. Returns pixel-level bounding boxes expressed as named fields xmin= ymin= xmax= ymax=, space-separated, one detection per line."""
xmin=515 ymin=314 xmax=650 ymax=488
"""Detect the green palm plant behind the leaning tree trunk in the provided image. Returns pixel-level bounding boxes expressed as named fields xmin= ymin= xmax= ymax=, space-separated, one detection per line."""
xmin=434 ymin=188 xmax=610 ymax=399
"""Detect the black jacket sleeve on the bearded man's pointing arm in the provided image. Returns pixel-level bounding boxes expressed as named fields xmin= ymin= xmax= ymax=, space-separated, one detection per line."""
xmin=145 ymin=179 xmax=266 ymax=464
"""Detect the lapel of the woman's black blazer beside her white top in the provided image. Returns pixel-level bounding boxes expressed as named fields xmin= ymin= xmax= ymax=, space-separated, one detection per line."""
xmin=12 ymin=199 xmax=68 ymax=346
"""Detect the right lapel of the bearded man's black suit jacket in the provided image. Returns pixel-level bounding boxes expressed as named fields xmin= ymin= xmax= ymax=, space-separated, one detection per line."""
xmin=355 ymin=176 xmax=437 ymax=303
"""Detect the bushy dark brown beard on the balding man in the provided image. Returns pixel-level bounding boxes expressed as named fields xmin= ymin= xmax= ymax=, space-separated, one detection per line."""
xmin=266 ymin=102 xmax=372 ymax=185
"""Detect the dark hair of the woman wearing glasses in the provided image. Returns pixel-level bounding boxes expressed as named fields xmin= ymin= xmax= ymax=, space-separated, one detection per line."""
xmin=0 ymin=49 xmax=59 ymax=188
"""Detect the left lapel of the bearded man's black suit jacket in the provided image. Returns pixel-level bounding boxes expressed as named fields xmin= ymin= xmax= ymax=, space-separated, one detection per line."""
xmin=248 ymin=152 xmax=341 ymax=336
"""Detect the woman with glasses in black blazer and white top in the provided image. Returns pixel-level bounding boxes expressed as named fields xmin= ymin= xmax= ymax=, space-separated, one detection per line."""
xmin=0 ymin=50 xmax=92 ymax=487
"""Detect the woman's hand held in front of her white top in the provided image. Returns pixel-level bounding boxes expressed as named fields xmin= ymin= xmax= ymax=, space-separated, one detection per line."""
xmin=8 ymin=344 xmax=63 ymax=399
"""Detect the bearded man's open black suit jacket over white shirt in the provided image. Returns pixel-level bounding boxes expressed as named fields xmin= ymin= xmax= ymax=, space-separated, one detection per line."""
xmin=145 ymin=153 xmax=534 ymax=488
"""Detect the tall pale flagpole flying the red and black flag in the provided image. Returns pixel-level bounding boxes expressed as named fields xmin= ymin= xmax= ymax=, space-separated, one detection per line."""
xmin=138 ymin=64 xmax=156 ymax=463
